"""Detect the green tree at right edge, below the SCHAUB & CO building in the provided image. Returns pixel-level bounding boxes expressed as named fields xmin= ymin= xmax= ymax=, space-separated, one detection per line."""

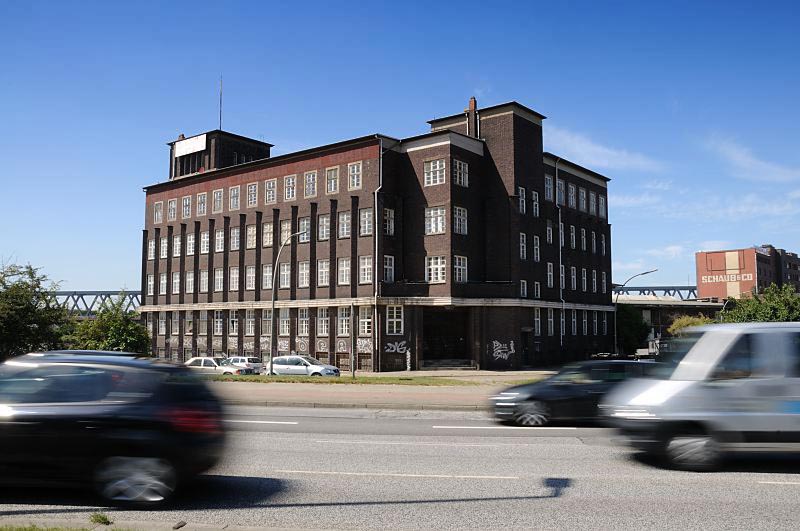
xmin=719 ymin=284 xmax=800 ymax=323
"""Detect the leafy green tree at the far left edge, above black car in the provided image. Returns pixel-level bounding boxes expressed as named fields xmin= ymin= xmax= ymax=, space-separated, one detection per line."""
xmin=0 ymin=265 xmax=74 ymax=360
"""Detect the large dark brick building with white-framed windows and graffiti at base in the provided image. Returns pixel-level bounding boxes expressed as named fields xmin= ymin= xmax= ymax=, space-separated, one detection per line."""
xmin=140 ymin=98 xmax=613 ymax=370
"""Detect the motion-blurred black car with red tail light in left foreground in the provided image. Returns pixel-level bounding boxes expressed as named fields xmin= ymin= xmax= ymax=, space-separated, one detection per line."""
xmin=0 ymin=352 xmax=225 ymax=505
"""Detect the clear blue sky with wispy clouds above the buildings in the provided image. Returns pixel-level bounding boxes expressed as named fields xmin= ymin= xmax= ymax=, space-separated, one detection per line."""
xmin=0 ymin=1 xmax=800 ymax=290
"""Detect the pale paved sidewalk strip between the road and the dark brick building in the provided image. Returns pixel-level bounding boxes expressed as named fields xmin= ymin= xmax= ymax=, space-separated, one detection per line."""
xmin=211 ymin=371 xmax=550 ymax=411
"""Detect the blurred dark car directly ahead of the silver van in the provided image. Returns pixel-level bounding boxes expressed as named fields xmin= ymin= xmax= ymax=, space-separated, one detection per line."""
xmin=490 ymin=360 xmax=653 ymax=426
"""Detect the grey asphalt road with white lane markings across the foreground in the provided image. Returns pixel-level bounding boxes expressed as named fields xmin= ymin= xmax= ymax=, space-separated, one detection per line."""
xmin=0 ymin=407 xmax=800 ymax=529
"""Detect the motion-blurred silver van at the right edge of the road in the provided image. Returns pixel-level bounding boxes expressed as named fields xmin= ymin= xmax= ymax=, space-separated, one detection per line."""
xmin=601 ymin=323 xmax=800 ymax=470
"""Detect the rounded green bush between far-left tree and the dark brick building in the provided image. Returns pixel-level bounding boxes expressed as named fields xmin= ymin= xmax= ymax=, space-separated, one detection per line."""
xmin=69 ymin=293 xmax=150 ymax=354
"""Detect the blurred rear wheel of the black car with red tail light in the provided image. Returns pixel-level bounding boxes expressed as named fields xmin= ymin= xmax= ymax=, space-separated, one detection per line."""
xmin=95 ymin=457 xmax=177 ymax=505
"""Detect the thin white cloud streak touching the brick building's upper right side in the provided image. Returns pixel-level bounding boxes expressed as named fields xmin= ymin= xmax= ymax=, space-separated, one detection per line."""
xmin=544 ymin=126 xmax=664 ymax=171
